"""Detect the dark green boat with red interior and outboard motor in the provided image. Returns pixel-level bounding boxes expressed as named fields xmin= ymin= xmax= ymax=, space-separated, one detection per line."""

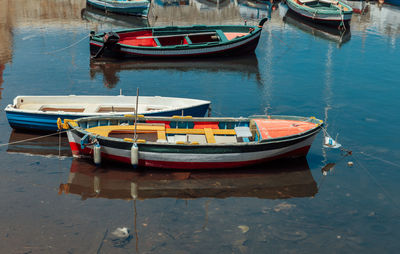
xmin=90 ymin=18 xmax=267 ymax=58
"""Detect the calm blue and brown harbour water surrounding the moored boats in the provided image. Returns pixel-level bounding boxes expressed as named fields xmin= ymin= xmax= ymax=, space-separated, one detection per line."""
xmin=0 ymin=0 xmax=400 ymax=253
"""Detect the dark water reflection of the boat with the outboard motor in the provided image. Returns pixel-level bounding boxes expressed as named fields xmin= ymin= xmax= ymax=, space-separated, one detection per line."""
xmin=90 ymin=54 xmax=261 ymax=88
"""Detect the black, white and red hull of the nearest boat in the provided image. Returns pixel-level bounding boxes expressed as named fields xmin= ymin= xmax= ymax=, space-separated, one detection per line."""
xmin=68 ymin=120 xmax=320 ymax=169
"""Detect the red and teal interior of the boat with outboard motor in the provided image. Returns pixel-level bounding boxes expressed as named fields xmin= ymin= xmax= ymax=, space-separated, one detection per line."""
xmin=118 ymin=29 xmax=250 ymax=47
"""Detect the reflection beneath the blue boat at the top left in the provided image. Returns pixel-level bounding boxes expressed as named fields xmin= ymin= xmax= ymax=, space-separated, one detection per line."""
xmin=81 ymin=6 xmax=149 ymax=28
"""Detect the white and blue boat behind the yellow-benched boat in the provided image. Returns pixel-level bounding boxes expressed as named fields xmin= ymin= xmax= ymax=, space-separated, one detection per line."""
xmin=5 ymin=95 xmax=210 ymax=131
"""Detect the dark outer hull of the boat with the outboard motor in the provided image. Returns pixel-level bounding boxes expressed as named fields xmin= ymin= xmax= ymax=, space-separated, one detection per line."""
xmin=90 ymin=26 xmax=261 ymax=58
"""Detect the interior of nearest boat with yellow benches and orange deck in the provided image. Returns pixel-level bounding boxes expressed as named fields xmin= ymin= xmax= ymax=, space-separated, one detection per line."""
xmin=79 ymin=117 xmax=316 ymax=145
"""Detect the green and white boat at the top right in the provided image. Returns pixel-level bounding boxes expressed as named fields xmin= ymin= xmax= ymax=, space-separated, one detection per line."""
xmin=286 ymin=0 xmax=353 ymax=28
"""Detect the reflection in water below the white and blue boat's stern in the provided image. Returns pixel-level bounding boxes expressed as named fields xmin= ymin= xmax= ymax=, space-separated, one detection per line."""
xmin=7 ymin=130 xmax=72 ymax=157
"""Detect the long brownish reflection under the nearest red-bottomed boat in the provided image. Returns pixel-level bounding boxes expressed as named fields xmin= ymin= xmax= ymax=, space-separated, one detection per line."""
xmin=59 ymin=158 xmax=318 ymax=200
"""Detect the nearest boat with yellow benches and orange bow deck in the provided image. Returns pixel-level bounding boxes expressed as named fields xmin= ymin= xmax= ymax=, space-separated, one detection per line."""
xmin=59 ymin=115 xmax=323 ymax=170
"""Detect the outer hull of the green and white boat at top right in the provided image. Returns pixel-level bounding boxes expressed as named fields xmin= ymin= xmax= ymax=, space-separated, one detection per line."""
xmin=286 ymin=0 xmax=352 ymax=27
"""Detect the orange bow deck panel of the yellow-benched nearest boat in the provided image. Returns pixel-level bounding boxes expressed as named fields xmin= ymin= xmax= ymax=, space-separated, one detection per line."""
xmin=254 ymin=119 xmax=315 ymax=139
